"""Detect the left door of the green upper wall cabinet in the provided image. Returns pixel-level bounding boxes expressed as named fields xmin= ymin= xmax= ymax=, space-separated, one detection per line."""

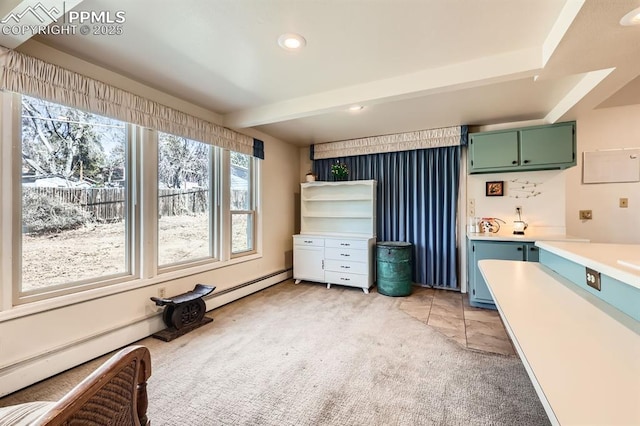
xmin=469 ymin=131 xmax=518 ymax=170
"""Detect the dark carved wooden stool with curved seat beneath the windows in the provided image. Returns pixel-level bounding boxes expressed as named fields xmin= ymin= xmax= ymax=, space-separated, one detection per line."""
xmin=151 ymin=284 xmax=216 ymax=342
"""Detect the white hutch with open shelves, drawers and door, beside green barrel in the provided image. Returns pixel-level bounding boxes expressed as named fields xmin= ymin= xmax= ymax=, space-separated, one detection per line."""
xmin=293 ymin=180 xmax=376 ymax=293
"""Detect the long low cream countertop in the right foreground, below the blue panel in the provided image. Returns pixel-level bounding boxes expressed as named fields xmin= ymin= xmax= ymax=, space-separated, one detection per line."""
xmin=478 ymin=260 xmax=640 ymax=425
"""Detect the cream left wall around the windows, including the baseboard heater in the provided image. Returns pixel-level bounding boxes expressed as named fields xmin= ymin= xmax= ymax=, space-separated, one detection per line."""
xmin=0 ymin=45 xmax=300 ymax=396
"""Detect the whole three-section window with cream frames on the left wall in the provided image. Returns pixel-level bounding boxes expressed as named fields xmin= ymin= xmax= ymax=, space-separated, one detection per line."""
xmin=0 ymin=92 xmax=259 ymax=304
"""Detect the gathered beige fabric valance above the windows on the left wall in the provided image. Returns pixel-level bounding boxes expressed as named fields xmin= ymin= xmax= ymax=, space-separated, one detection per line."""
xmin=0 ymin=49 xmax=254 ymax=155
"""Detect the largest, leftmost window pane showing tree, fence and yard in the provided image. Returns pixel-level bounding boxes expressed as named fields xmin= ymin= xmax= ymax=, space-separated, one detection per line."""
xmin=20 ymin=96 xmax=130 ymax=292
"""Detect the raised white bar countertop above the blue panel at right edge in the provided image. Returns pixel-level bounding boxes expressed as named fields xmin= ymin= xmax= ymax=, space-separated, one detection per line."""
xmin=536 ymin=241 xmax=640 ymax=288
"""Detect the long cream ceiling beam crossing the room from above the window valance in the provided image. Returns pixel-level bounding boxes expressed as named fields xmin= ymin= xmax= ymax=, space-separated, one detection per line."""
xmin=224 ymin=48 xmax=542 ymax=129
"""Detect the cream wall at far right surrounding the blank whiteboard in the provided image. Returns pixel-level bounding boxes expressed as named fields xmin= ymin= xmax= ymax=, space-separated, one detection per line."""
xmin=566 ymin=105 xmax=640 ymax=244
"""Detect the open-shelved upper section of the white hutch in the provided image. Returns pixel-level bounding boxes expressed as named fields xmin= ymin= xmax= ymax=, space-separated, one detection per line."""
xmin=300 ymin=180 xmax=376 ymax=237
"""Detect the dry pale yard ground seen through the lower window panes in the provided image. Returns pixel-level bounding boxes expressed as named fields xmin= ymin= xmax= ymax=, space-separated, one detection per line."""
xmin=22 ymin=214 xmax=247 ymax=292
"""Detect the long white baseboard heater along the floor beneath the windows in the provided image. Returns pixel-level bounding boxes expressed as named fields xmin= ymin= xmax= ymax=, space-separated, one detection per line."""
xmin=0 ymin=270 xmax=292 ymax=397
